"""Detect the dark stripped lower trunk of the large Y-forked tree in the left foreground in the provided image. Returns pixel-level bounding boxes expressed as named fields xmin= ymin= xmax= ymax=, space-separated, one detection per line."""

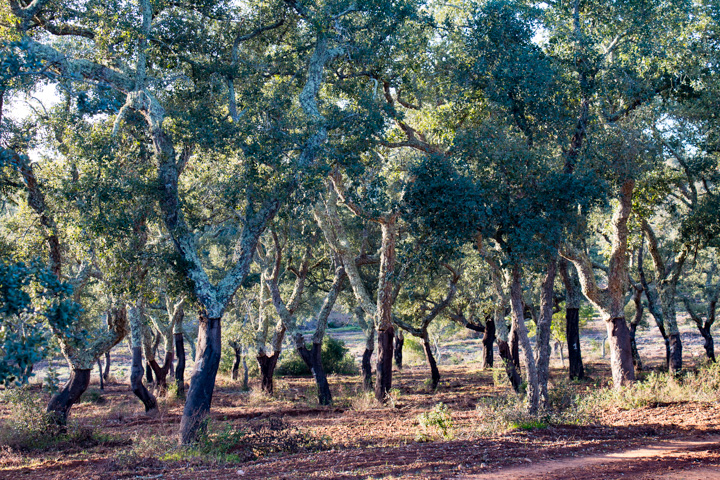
xmin=180 ymin=312 xmax=222 ymax=444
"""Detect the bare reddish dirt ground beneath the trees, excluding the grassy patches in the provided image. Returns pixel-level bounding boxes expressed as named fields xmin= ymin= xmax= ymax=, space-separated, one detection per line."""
xmin=0 ymin=366 xmax=720 ymax=480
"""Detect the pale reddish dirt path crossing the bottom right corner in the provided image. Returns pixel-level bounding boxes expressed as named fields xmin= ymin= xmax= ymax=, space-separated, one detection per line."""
xmin=458 ymin=436 xmax=720 ymax=480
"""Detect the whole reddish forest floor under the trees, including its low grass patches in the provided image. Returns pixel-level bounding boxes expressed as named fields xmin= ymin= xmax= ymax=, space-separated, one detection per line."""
xmin=0 ymin=318 xmax=720 ymax=480
